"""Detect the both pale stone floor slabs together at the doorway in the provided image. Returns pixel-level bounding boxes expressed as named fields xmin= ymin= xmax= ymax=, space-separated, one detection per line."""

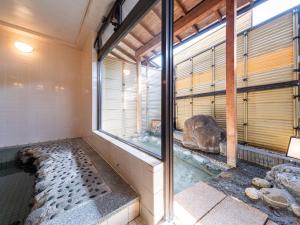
xmin=174 ymin=182 xmax=276 ymax=225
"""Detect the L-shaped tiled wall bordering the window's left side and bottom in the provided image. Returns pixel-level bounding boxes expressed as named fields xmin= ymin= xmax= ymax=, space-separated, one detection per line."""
xmin=81 ymin=38 xmax=163 ymax=225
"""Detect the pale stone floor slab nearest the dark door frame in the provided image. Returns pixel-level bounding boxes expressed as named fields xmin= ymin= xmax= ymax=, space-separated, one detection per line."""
xmin=174 ymin=182 xmax=226 ymax=225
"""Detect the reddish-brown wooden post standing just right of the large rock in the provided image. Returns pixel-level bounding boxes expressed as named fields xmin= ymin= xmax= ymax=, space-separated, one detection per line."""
xmin=226 ymin=0 xmax=237 ymax=167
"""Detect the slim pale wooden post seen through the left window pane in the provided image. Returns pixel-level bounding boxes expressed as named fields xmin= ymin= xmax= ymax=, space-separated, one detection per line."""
xmin=136 ymin=57 xmax=142 ymax=134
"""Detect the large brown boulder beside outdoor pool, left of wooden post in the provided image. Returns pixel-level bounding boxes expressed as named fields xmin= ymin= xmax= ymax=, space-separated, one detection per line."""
xmin=182 ymin=115 xmax=226 ymax=153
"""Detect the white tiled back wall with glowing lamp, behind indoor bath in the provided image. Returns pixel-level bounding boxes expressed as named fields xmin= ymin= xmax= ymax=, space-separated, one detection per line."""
xmin=0 ymin=28 xmax=81 ymax=147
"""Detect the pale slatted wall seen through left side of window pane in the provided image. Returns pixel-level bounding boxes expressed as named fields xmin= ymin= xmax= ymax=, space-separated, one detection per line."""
xmin=102 ymin=57 xmax=137 ymax=137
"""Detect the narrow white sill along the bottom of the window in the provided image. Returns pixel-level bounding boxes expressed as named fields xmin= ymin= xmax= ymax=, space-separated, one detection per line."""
xmin=93 ymin=130 xmax=162 ymax=168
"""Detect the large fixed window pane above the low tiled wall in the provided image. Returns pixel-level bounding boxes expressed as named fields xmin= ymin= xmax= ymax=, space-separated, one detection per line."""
xmin=101 ymin=2 xmax=161 ymax=157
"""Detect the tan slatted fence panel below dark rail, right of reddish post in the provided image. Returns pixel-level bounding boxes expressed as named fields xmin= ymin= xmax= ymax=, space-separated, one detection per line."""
xmin=248 ymin=88 xmax=294 ymax=152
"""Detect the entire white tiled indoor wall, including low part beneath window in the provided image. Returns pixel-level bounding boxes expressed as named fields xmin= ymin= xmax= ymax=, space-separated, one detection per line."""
xmin=0 ymin=20 xmax=163 ymax=225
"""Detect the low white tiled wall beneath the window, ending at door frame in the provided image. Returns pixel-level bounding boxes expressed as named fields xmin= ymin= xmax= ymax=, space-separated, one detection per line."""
xmin=85 ymin=133 xmax=164 ymax=225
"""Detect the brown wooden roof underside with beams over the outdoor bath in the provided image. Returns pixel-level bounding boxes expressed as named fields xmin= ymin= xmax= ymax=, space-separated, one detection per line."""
xmin=110 ymin=0 xmax=253 ymax=67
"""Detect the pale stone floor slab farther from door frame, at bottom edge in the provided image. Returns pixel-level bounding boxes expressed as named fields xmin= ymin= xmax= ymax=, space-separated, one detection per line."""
xmin=196 ymin=196 xmax=268 ymax=225
